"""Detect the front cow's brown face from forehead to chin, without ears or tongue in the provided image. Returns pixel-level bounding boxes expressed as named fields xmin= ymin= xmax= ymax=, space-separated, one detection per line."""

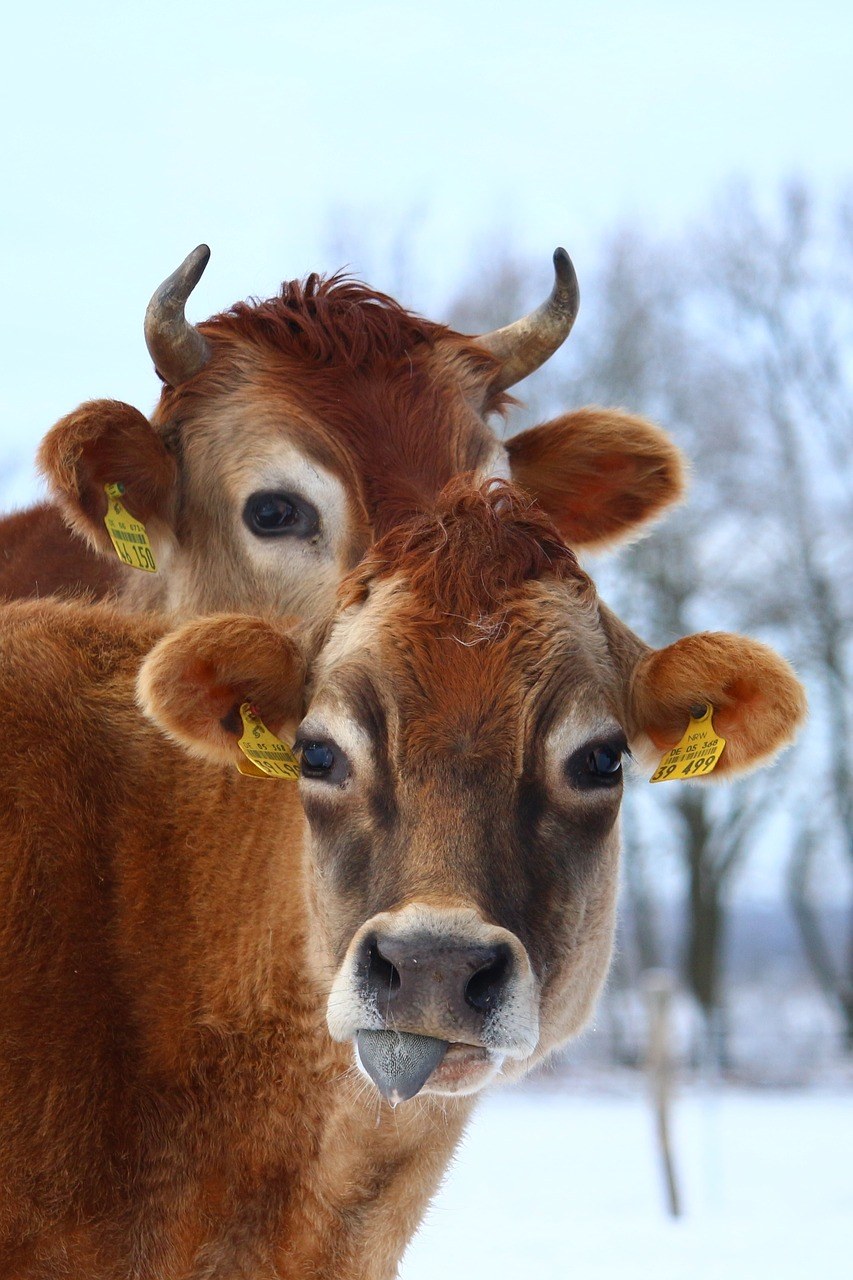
xmin=298 ymin=576 xmax=626 ymax=1093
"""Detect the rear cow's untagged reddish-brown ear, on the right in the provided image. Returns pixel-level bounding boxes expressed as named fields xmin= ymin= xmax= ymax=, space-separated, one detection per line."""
xmin=506 ymin=407 xmax=685 ymax=550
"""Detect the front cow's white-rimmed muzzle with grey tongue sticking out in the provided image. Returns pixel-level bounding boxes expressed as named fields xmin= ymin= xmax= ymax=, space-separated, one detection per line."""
xmin=327 ymin=904 xmax=539 ymax=1102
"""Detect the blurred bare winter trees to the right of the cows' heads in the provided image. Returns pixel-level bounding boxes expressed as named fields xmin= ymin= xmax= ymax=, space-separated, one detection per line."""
xmin=563 ymin=183 xmax=853 ymax=1046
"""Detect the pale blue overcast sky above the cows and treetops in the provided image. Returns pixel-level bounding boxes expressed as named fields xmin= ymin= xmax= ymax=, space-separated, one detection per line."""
xmin=0 ymin=0 xmax=853 ymax=504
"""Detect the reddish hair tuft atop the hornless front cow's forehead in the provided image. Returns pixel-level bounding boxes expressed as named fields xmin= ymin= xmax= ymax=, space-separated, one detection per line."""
xmin=341 ymin=476 xmax=594 ymax=620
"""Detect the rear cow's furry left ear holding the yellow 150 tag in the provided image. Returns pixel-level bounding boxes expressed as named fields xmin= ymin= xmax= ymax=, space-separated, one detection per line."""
xmin=37 ymin=401 xmax=177 ymax=556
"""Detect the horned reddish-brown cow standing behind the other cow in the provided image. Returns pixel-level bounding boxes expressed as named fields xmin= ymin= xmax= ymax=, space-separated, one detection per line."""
xmin=0 ymin=246 xmax=683 ymax=618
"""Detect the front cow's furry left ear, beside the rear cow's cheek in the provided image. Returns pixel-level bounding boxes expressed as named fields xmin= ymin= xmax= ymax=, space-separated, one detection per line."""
xmin=137 ymin=614 xmax=306 ymax=764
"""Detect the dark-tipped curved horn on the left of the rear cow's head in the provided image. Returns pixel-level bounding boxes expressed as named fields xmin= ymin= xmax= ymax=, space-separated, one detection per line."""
xmin=145 ymin=244 xmax=210 ymax=387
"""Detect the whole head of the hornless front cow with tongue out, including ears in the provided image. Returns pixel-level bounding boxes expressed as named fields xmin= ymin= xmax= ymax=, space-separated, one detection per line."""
xmin=141 ymin=480 xmax=804 ymax=1100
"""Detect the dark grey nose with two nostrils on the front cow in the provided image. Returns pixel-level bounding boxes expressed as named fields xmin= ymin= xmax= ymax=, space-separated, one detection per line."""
xmin=361 ymin=934 xmax=514 ymax=1042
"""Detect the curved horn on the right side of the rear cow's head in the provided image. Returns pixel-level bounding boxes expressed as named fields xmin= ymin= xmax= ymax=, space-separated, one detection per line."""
xmin=476 ymin=248 xmax=580 ymax=392
